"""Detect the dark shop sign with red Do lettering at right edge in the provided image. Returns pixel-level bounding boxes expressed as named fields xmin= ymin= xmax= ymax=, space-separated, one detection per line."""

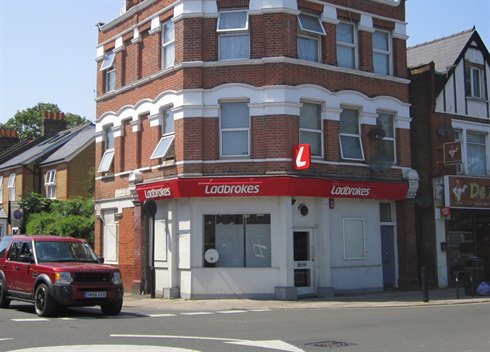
xmin=444 ymin=176 xmax=490 ymax=208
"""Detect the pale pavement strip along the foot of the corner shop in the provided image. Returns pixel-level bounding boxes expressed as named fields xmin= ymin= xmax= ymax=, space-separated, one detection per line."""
xmin=124 ymin=288 xmax=490 ymax=312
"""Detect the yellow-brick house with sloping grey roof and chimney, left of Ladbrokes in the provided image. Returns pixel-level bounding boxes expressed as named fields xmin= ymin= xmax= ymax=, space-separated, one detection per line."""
xmin=0 ymin=112 xmax=95 ymax=234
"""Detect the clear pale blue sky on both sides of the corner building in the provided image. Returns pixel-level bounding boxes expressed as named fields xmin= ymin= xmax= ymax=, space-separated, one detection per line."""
xmin=0 ymin=0 xmax=490 ymax=123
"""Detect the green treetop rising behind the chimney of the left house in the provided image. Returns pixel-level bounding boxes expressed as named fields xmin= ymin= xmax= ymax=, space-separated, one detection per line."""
xmin=0 ymin=103 xmax=90 ymax=140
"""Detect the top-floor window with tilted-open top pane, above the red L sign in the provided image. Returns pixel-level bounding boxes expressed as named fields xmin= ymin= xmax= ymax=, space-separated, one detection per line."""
xmin=297 ymin=13 xmax=326 ymax=62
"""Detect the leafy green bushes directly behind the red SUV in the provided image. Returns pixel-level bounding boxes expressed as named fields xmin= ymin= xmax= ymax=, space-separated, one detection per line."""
xmin=20 ymin=193 xmax=95 ymax=244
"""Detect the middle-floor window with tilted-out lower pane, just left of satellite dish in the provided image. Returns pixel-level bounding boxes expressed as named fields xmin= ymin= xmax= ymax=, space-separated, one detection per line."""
xmin=339 ymin=109 xmax=364 ymax=160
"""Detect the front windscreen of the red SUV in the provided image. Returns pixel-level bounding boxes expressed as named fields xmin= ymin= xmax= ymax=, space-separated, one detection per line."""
xmin=34 ymin=241 xmax=98 ymax=263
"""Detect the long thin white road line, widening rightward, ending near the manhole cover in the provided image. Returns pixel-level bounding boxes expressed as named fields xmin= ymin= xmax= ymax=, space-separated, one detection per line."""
xmin=110 ymin=334 xmax=305 ymax=352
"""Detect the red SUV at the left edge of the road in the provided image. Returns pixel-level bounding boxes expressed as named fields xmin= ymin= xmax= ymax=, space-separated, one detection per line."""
xmin=0 ymin=235 xmax=124 ymax=317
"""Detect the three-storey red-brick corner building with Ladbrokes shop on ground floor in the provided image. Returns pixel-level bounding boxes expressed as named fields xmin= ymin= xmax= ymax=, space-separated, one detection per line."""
xmin=96 ymin=0 xmax=418 ymax=299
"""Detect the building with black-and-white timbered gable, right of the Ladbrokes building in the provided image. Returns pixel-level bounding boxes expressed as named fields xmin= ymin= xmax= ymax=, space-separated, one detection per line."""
xmin=407 ymin=28 xmax=490 ymax=287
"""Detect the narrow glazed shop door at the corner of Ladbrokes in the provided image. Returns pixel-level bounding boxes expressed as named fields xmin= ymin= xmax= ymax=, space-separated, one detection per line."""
xmin=293 ymin=230 xmax=315 ymax=296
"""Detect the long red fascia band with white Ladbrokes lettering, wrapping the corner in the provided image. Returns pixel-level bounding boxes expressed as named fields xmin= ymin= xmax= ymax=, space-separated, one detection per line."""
xmin=136 ymin=176 xmax=408 ymax=202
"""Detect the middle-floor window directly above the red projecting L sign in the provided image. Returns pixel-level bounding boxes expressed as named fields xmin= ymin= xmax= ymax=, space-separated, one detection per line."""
xmin=299 ymin=103 xmax=323 ymax=157
